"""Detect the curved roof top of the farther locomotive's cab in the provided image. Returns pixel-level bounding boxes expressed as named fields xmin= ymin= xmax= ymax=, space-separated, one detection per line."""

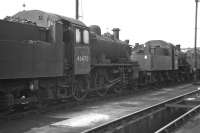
xmin=145 ymin=40 xmax=172 ymax=48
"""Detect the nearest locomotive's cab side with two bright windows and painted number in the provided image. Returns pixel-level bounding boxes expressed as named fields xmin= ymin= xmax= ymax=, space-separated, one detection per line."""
xmin=63 ymin=24 xmax=90 ymax=75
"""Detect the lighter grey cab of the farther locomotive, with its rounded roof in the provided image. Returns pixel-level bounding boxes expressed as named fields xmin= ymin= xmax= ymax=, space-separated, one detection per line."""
xmin=131 ymin=40 xmax=178 ymax=71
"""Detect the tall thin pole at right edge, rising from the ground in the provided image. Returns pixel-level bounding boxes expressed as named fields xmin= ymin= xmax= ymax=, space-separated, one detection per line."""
xmin=194 ymin=0 xmax=199 ymax=81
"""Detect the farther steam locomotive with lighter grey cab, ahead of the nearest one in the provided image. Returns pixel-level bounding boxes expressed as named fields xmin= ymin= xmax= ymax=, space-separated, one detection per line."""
xmin=131 ymin=40 xmax=193 ymax=86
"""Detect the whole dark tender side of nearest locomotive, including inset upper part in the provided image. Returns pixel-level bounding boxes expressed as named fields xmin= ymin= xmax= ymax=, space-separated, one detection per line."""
xmin=0 ymin=16 xmax=64 ymax=79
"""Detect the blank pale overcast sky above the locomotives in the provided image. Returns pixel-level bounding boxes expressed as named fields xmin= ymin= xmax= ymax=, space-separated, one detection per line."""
xmin=0 ymin=0 xmax=200 ymax=47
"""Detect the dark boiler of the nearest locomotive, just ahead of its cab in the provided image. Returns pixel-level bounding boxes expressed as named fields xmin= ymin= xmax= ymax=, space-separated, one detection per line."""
xmin=90 ymin=33 xmax=131 ymax=64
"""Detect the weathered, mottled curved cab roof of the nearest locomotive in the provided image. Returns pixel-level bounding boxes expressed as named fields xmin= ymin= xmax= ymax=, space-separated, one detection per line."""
xmin=12 ymin=10 xmax=86 ymax=27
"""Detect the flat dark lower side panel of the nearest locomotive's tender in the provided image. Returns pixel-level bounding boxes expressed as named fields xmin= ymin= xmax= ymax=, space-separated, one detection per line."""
xmin=0 ymin=41 xmax=63 ymax=79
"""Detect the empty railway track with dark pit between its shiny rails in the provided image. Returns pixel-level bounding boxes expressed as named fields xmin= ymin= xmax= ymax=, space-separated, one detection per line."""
xmin=81 ymin=87 xmax=200 ymax=133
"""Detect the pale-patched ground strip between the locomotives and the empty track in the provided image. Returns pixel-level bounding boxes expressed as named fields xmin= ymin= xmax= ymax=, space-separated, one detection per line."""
xmin=0 ymin=84 xmax=197 ymax=133
